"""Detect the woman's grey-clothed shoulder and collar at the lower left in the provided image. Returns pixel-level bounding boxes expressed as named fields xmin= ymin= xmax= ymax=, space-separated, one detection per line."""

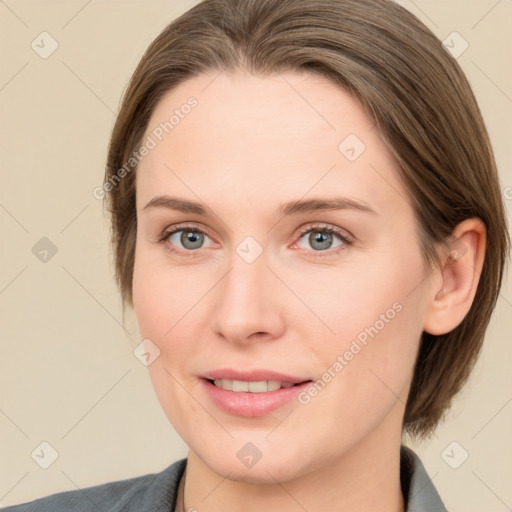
xmin=1 ymin=458 xmax=187 ymax=512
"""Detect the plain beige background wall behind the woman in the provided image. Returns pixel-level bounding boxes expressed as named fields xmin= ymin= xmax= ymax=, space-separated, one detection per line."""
xmin=0 ymin=0 xmax=512 ymax=512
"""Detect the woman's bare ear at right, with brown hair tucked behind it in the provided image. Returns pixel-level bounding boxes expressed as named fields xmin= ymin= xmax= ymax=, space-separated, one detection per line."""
xmin=423 ymin=218 xmax=487 ymax=335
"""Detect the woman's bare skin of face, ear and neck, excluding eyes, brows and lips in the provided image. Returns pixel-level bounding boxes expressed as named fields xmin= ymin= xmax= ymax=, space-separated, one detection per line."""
xmin=133 ymin=71 xmax=485 ymax=512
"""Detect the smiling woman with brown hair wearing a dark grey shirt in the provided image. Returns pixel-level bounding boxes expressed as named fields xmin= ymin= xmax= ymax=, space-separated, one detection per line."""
xmin=7 ymin=0 xmax=510 ymax=512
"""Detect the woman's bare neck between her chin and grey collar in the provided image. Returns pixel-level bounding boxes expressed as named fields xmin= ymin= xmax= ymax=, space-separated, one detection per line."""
xmin=184 ymin=430 xmax=405 ymax=512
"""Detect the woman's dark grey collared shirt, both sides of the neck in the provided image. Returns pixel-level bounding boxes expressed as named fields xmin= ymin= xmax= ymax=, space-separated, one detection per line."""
xmin=2 ymin=446 xmax=448 ymax=512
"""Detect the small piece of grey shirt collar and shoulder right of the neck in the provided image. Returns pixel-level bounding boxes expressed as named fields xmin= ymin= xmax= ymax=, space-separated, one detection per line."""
xmin=400 ymin=445 xmax=448 ymax=512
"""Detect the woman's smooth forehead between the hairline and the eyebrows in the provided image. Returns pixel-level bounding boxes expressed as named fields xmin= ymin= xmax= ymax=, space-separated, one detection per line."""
xmin=137 ymin=72 xmax=407 ymax=218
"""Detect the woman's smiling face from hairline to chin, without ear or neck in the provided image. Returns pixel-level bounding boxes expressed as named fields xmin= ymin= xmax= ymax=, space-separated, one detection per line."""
xmin=133 ymin=72 xmax=431 ymax=482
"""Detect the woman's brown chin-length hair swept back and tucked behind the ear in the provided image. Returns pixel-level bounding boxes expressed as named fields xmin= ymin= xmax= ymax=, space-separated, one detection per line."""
xmin=105 ymin=0 xmax=510 ymax=436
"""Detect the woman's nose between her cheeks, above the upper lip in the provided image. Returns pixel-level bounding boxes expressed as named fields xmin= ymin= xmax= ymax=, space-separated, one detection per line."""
xmin=211 ymin=247 xmax=286 ymax=344
